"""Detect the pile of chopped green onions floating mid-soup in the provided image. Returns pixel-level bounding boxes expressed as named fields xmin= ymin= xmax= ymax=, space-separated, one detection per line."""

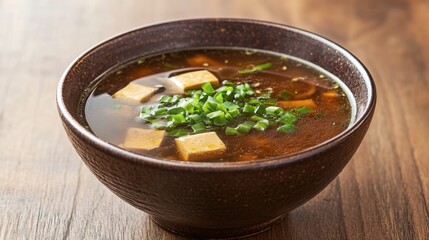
xmin=139 ymin=77 xmax=312 ymax=137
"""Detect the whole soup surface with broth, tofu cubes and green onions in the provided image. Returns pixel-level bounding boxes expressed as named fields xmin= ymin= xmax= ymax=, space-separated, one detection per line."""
xmin=80 ymin=48 xmax=355 ymax=162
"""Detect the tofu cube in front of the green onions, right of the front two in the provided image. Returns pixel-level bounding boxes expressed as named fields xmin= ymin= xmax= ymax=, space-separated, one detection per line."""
xmin=175 ymin=132 xmax=226 ymax=161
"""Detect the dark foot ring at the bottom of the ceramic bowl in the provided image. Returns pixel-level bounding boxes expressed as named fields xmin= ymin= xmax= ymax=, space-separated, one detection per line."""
xmin=150 ymin=216 xmax=284 ymax=239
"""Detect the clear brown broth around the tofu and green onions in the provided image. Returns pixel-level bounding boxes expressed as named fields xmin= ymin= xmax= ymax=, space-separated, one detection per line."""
xmin=81 ymin=49 xmax=354 ymax=162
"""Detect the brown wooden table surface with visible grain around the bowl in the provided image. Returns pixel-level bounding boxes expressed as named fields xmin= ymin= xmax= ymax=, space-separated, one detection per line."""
xmin=0 ymin=0 xmax=429 ymax=239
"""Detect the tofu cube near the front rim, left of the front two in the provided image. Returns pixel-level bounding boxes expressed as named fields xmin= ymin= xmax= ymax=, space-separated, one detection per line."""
xmin=123 ymin=128 xmax=165 ymax=150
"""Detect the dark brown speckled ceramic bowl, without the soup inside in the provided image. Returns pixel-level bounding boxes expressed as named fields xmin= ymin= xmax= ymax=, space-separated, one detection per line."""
xmin=57 ymin=19 xmax=376 ymax=238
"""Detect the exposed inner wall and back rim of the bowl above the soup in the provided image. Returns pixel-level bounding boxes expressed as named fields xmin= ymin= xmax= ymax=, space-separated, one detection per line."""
xmin=58 ymin=19 xmax=375 ymax=165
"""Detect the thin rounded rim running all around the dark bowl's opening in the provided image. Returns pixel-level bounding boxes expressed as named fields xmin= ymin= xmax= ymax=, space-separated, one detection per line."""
xmin=56 ymin=18 xmax=377 ymax=171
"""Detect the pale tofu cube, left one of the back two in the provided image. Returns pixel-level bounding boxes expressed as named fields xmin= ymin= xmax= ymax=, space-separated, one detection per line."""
xmin=112 ymin=83 xmax=156 ymax=102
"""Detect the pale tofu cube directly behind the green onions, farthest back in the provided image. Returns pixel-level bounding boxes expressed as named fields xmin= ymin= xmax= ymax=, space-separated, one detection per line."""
xmin=169 ymin=70 xmax=219 ymax=91
